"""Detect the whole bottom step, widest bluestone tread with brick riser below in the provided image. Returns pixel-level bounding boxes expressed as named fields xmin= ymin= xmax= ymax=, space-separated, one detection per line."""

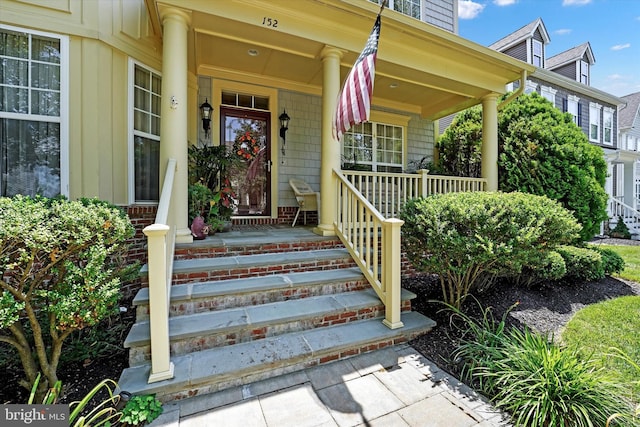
xmin=118 ymin=312 xmax=435 ymax=404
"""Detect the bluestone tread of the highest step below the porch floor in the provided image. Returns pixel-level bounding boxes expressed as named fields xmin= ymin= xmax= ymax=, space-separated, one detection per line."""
xmin=140 ymin=248 xmax=350 ymax=274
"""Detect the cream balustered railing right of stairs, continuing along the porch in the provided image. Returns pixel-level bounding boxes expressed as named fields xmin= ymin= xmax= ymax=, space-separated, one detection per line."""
xmin=334 ymin=170 xmax=487 ymax=329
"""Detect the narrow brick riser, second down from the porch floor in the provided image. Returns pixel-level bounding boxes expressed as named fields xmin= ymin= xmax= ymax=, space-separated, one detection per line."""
xmin=165 ymin=258 xmax=356 ymax=286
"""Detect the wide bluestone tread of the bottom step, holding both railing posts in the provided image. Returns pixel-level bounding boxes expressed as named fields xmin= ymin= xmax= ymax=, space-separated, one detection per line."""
xmin=118 ymin=312 xmax=435 ymax=394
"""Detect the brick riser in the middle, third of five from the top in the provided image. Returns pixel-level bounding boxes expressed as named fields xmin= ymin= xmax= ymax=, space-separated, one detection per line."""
xmin=136 ymin=280 xmax=369 ymax=322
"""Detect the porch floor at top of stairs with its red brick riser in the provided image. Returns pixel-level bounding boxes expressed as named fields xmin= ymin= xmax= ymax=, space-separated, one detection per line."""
xmin=174 ymin=227 xmax=344 ymax=260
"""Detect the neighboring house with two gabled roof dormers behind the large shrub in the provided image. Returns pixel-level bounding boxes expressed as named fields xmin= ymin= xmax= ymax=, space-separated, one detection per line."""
xmin=489 ymin=18 xmax=640 ymax=231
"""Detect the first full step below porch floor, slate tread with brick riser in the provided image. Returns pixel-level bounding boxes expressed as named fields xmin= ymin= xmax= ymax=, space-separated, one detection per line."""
xmin=140 ymin=247 xmax=356 ymax=286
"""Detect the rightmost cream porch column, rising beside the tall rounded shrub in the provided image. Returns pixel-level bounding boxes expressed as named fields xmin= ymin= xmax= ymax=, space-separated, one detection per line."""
xmin=482 ymin=93 xmax=498 ymax=191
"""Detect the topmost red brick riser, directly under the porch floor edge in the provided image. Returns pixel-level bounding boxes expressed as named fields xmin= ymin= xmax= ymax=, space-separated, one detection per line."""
xmin=175 ymin=240 xmax=344 ymax=260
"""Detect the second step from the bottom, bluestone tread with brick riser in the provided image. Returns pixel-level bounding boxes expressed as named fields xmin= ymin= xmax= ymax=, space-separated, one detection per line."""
xmin=124 ymin=289 xmax=415 ymax=366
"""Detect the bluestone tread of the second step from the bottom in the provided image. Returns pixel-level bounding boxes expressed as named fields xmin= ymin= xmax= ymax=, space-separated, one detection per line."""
xmin=124 ymin=289 xmax=415 ymax=348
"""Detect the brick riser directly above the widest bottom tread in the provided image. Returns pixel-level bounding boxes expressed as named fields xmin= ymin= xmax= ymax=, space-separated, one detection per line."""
xmin=129 ymin=301 xmax=411 ymax=366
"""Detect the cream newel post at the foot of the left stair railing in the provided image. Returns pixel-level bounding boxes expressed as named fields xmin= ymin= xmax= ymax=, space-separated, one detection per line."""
xmin=143 ymin=224 xmax=174 ymax=383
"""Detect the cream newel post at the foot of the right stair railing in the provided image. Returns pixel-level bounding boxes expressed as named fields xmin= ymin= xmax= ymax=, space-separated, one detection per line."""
xmin=382 ymin=218 xmax=404 ymax=329
